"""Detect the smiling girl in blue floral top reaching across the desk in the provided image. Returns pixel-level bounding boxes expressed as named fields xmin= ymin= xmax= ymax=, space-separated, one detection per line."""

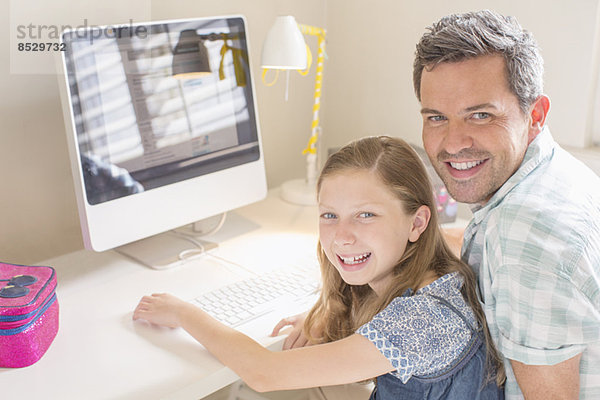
xmin=134 ymin=137 xmax=503 ymax=400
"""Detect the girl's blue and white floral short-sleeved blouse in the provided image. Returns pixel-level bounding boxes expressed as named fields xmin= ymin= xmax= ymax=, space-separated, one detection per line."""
xmin=356 ymin=272 xmax=478 ymax=383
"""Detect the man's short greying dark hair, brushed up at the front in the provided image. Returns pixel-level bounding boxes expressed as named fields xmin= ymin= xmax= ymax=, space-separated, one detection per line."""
xmin=413 ymin=10 xmax=544 ymax=113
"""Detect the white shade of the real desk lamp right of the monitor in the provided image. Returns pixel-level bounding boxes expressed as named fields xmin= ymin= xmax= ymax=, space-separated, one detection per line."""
xmin=261 ymin=15 xmax=307 ymax=69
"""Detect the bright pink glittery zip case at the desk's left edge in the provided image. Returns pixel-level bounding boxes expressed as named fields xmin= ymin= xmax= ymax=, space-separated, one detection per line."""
xmin=0 ymin=263 xmax=58 ymax=368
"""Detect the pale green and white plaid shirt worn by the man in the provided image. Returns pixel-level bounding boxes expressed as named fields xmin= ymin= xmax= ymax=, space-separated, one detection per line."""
xmin=462 ymin=128 xmax=600 ymax=399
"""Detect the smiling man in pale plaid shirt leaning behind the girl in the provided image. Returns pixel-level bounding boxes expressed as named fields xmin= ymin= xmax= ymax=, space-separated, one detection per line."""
xmin=413 ymin=11 xmax=600 ymax=400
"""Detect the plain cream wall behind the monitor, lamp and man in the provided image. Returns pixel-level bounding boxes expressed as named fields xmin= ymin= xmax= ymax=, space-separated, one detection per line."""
xmin=0 ymin=0 xmax=598 ymax=263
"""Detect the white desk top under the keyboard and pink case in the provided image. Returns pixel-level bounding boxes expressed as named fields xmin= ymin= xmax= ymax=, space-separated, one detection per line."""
xmin=0 ymin=191 xmax=318 ymax=400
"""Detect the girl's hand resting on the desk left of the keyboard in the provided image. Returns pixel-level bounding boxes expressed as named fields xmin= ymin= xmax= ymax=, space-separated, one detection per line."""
xmin=133 ymin=293 xmax=192 ymax=328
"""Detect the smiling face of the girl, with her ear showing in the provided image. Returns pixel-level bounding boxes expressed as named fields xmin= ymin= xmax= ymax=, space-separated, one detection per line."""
xmin=319 ymin=169 xmax=427 ymax=295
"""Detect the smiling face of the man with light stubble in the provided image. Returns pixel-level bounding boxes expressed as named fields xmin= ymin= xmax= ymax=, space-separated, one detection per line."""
xmin=421 ymin=55 xmax=533 ymax=205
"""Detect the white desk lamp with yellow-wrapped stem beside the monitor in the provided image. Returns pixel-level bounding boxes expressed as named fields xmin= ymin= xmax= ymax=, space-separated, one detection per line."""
xmin=261 ymin=15 xmax=326 ymax=205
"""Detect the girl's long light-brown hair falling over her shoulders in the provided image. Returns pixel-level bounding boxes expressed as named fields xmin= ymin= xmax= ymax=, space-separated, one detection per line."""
xmin=304 ymin=136 xmax=505 ymax=383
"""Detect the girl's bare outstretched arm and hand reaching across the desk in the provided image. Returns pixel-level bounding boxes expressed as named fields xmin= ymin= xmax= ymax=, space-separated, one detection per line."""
xmin=133 ymin=294 xmax=394 ymax=392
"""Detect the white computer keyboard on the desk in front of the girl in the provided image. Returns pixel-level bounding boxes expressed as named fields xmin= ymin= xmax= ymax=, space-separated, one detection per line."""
xmin=192 ymin=267 xmax=319 ymax=327
